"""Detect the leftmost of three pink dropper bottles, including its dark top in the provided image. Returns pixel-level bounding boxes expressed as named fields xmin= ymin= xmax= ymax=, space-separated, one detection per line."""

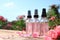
xmin=26 ymin=10 xmax=32 ymax=35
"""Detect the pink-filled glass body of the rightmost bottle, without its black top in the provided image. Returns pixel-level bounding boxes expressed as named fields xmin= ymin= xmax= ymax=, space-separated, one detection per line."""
xmin=40 ymin=18 xmax=49 ymax=35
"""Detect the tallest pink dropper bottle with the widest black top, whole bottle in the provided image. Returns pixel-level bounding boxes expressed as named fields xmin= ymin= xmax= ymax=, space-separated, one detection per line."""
xmin=40 ymin=8 xmax=49 ymax=36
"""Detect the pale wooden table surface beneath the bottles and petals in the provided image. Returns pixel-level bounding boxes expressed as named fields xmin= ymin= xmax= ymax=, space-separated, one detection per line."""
xmin=0 ymin=29 xmax=44 ymax=40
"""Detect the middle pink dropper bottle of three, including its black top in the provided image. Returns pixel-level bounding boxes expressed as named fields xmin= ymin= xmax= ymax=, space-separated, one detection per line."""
xmin=33 ymin=9 xmax=40 ymax=35
